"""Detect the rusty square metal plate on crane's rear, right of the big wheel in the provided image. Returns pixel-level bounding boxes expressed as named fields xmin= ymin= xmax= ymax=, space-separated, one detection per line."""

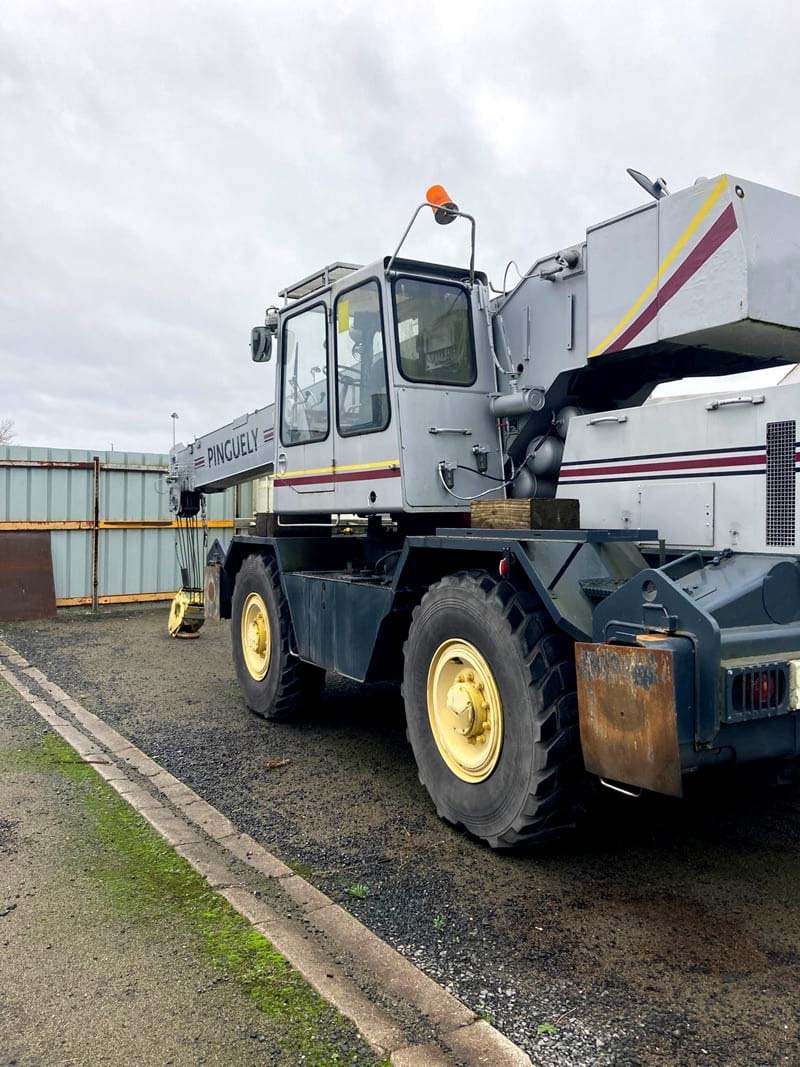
xmin=575 ymin=643 xmax=683 ymax=796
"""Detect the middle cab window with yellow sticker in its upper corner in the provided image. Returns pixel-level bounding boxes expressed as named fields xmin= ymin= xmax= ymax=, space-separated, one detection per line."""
xmin=334 ymin=282 xmax=389 ymax=437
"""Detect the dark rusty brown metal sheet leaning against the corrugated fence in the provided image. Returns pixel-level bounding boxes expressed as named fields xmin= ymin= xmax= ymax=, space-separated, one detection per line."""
xmin=0 ymin=530 xmax=55 ymax=622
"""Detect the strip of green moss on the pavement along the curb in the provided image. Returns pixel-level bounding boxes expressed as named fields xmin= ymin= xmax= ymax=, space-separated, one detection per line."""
xmin=0 ymin=734 xmax=388 ymax=1067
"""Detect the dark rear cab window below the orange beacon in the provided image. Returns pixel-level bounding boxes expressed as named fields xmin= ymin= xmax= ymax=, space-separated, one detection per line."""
xmin=394 ymin=277 xmax=477 ymax=385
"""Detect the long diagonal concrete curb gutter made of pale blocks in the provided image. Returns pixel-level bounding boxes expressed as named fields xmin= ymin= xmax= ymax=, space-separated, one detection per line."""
xmin=0 ymin=641 xmax=539 ymax=1067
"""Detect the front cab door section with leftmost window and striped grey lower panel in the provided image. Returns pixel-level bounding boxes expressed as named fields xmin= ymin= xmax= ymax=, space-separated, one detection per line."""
xmin=275 ymin=294 xmax=334 ymax=501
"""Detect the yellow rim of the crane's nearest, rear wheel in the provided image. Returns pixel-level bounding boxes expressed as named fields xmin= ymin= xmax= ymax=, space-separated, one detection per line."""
xmin=428 ymin=640 xmax=502 ymax=782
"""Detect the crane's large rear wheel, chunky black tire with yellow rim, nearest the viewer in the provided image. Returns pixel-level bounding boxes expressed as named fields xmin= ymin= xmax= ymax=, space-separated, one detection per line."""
xmin=403 ymin=571 xmax=583 ymax=848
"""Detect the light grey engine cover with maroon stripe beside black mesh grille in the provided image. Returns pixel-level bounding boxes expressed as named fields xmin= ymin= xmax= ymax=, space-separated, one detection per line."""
xmin=558 ymin=385 xmax=800 ymax=554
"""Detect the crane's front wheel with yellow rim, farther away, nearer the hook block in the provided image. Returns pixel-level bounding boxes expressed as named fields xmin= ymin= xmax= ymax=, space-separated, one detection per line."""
xmin=230 ymin=556 xmax=325 ymax=719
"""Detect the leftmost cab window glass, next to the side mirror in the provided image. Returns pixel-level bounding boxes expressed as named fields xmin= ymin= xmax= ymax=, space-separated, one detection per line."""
xmin=281 ymin=304 xmax=329 ymax=445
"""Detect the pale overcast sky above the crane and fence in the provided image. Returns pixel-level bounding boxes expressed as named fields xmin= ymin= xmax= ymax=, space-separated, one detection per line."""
xmin=0 ymin=0 xmax=800 ymax=450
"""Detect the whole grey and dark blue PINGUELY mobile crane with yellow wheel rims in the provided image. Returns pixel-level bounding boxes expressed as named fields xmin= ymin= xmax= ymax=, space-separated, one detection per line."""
xmin=169 ymin=172 xmax=800 ymax=848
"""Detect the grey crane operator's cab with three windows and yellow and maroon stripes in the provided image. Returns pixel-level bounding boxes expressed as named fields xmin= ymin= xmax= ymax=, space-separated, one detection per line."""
xmin=274 ymin=258 xmax=502 ymax=515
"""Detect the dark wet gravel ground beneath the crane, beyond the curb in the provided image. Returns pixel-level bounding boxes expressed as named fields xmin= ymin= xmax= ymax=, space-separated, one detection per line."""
xmin=2 ymin=607 xmax=800 ymax=1067
